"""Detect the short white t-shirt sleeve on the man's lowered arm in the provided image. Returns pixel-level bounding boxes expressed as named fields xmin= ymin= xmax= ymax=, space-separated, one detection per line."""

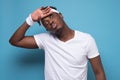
xmin=87 ymin=36 xmax=99 ymax=59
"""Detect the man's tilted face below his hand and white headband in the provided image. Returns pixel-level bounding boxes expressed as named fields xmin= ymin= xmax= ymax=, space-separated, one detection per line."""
xmin=41 ymin=12 xmax=63 ymax=33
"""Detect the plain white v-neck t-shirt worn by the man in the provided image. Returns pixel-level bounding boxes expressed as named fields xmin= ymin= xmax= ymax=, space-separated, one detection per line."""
xmin=34 ymin=31 xmax=99 ymax=80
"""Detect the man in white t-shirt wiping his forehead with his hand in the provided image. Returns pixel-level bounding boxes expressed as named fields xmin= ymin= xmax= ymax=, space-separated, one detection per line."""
xmin=10 ymin=7 xmax=106 ymax=80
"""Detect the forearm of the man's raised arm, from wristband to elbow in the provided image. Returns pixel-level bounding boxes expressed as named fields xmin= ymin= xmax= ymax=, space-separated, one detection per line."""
xmin=9 ymin=22 xmax=29 ymax=45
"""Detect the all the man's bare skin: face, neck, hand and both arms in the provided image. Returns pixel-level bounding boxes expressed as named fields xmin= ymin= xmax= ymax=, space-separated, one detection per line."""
xmin=9 ymin=7 xmax=106 ymax=80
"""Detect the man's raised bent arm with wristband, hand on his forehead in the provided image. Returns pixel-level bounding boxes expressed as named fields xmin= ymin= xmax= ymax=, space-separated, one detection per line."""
xmin=9 ymin=7 xmax=51 ymax=48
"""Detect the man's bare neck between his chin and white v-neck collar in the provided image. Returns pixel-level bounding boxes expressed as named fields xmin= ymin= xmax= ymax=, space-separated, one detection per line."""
xmin=56 ymin=25 xmax=74 ymax=42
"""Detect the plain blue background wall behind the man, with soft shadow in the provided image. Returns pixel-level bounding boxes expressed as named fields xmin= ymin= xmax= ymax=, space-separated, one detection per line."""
xmin=0 ymin=0 xmax=120 ymax=80
